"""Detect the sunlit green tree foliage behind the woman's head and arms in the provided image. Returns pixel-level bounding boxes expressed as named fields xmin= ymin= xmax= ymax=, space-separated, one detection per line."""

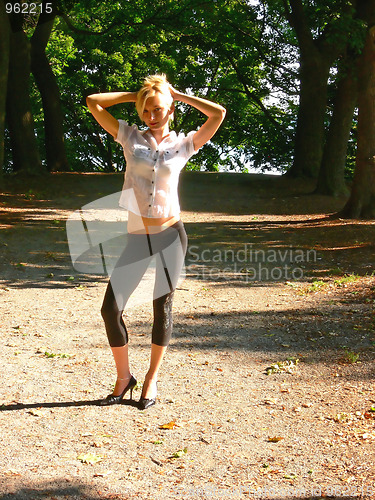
xmin=2 ymin=0 xmax=365 ymax=177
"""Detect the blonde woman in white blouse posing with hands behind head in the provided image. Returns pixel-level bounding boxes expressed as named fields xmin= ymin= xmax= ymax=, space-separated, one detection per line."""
xmin=86 ymin=75 xmax=226 ymax=409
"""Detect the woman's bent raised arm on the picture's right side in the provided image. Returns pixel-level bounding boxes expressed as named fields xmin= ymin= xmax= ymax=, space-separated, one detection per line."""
xmin=170 ymin=86 xmax=226 ymax=150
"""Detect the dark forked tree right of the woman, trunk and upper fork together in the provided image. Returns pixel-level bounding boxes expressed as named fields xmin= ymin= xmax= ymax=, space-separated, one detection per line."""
xmin=283 ymin=0 xmax=354 ymax=177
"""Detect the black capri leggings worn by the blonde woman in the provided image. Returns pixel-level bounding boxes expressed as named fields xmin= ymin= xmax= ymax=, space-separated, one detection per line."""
xmin=101 ymin=220 xmax=188 ymax=347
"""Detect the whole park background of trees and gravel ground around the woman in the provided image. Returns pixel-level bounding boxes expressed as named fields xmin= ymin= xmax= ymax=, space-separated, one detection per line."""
xmin=0 ymin=0 xmax=375 ymax=500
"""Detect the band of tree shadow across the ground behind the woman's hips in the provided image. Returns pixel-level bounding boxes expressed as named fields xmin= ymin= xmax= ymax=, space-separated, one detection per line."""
xmin=0 ymin=219 xmax=375 ymax=288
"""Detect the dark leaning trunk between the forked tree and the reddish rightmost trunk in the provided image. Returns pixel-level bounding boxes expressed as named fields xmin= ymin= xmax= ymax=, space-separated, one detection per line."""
xmin=316 ymin=60 xmax=357 ymax=196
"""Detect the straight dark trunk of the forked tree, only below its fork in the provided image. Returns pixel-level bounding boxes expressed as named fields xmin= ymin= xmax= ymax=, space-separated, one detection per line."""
xmin=287 ymin=54 xmax=330 ymax=178
